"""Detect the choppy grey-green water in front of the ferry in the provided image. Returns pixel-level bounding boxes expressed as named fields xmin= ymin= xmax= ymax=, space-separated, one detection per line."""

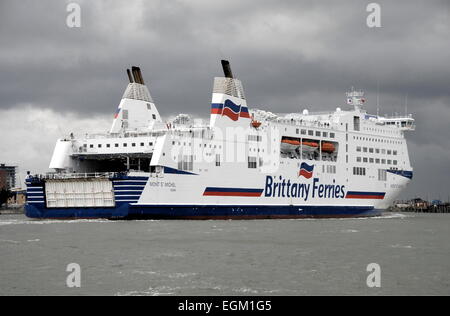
xmin=0 ymin=214 xmax=450 ymax=295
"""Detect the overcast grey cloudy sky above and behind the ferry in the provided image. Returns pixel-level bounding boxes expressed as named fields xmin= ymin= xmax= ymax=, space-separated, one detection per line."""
xmin=0 ymin=0 xmax=450 ymax=200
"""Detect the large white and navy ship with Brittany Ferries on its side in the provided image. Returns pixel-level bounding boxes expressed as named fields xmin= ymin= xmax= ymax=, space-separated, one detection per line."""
xmin=26 ymin=60 xmax=415 ymax=219
